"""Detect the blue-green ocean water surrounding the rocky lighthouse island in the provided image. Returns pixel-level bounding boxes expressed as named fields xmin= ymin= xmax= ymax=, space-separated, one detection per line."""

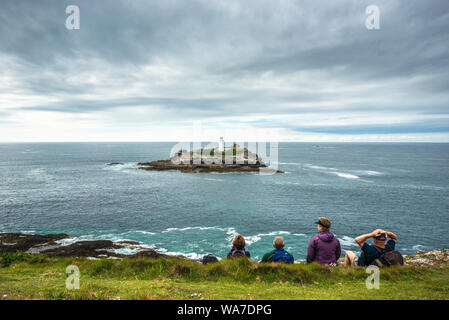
xmin=0 ymin=143 xmax=449 ymax=260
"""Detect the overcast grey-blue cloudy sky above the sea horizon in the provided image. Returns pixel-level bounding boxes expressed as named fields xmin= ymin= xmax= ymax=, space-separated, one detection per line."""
xmin=0 ymin=0 xmax=449 ymax=142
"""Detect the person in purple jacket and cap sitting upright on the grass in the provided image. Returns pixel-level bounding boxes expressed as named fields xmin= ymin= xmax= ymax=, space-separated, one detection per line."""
xmin=307 ymin=217 xmax=341 ymax=266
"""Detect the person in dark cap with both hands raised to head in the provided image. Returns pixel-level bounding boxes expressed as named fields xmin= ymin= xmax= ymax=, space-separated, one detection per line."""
xmin=345 ymin=229 xmax=397 ymax=267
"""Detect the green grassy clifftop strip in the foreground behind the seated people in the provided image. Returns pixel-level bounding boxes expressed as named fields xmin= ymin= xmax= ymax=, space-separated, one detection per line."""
xmin=0 ymin=253 xmax=449 ymax=300
